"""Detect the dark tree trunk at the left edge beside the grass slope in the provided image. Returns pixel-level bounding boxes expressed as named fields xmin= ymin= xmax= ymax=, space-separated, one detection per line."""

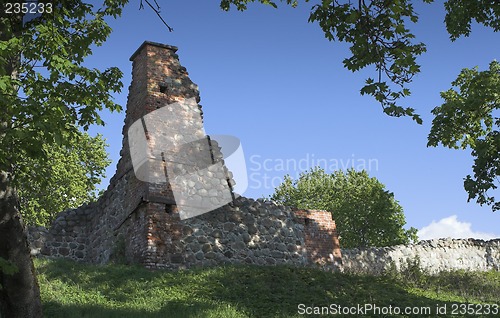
xmin=0 ymin=169 xmax=42 ymax=318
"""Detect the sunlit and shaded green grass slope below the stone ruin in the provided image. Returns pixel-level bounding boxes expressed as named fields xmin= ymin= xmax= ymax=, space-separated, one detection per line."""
xmin=35 ymin=259 xmax=500 ymax=318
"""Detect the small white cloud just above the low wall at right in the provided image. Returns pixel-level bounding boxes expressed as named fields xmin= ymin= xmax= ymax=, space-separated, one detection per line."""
xmin=418 ymin=215 xmax=500 ymax=240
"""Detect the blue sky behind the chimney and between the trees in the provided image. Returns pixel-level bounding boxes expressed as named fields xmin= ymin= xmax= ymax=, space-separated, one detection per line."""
xmin=87 ymin=0 xmax=500 ymax=238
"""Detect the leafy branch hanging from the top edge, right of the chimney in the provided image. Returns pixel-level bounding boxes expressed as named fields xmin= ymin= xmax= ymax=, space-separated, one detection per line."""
xmin=221 ymin=0 xmax=426 ymax=124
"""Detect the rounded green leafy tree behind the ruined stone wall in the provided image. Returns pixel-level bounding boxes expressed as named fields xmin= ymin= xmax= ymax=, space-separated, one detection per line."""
xmin=271 ymin=168 xmax=417 ymax=248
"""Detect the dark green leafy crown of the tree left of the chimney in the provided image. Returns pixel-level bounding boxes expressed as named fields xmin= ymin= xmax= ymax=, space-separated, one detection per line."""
xmin=0 ymin=0 xmax=126 ymax=169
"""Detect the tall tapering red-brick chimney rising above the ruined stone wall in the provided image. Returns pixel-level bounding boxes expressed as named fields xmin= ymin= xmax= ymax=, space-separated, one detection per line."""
xmin=118 ymin=41 xmax=234 ymax=219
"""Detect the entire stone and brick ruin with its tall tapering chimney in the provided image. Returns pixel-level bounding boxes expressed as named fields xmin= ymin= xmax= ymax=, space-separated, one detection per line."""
xmin=29 ymin=42 xmax=341 ymax=269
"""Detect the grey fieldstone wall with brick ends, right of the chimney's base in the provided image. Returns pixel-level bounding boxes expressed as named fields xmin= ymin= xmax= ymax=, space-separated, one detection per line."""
xmin=128 ymin=197 xmax=340 ymax=269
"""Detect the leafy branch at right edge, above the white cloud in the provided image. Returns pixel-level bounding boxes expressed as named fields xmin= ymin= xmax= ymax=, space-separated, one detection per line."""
xmin=428 ymin=61 xmax=500 ymax=211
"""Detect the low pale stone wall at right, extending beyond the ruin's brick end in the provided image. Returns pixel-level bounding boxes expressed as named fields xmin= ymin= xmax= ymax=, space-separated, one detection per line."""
xmin=342 ymin=238 xmax=500 ymax=275
